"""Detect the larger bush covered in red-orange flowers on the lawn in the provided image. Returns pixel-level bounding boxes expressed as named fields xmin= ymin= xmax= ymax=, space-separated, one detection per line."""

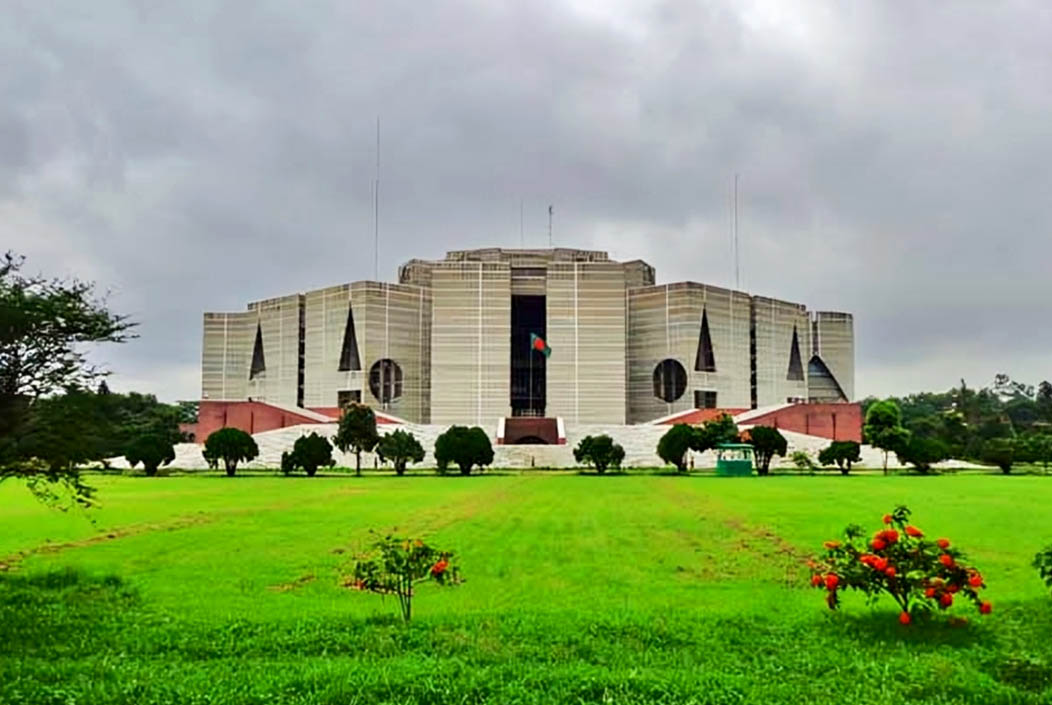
xmin=809 ymin=506 xmax=993 ymax=624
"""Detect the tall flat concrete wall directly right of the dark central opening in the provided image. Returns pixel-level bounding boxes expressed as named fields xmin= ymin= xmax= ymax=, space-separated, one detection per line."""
xmin=545 ymin=262 xmax=626 ymax=424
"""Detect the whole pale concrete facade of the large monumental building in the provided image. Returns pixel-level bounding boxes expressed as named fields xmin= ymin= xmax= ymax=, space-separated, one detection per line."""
xmin=202 ymin=248 xmax=854 ymax=427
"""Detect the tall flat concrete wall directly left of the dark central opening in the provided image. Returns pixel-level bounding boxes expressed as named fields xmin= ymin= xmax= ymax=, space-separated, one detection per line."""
xmin=430 ymin=261 xmax=511 ymax=428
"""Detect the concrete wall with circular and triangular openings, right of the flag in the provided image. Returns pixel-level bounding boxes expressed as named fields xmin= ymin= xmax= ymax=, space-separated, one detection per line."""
xmin=628 ymin=282 xmax=750 ymax=423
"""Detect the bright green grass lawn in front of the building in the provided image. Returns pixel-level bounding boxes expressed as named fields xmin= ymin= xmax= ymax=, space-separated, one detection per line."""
xmin=0 ymin=475 xmax=1052 ymax=704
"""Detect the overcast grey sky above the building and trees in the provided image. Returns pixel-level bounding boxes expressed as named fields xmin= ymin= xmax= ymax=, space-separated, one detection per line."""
xmin=0 ymin=0 xmax=1052 ymax=400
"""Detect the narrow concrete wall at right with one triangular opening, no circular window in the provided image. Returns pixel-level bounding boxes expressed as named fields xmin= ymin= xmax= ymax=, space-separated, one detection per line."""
xmin=752 ymin=297 xmax=811 ymax=406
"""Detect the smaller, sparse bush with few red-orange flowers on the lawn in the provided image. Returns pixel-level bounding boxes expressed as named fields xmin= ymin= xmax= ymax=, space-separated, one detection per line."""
xmin=344 ymin=536 xmax=464 ymax=622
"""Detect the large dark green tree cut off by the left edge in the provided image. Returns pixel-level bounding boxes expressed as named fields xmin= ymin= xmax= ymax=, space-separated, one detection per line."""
xmin=0 ymin=253 xmax=134 ymax=504
